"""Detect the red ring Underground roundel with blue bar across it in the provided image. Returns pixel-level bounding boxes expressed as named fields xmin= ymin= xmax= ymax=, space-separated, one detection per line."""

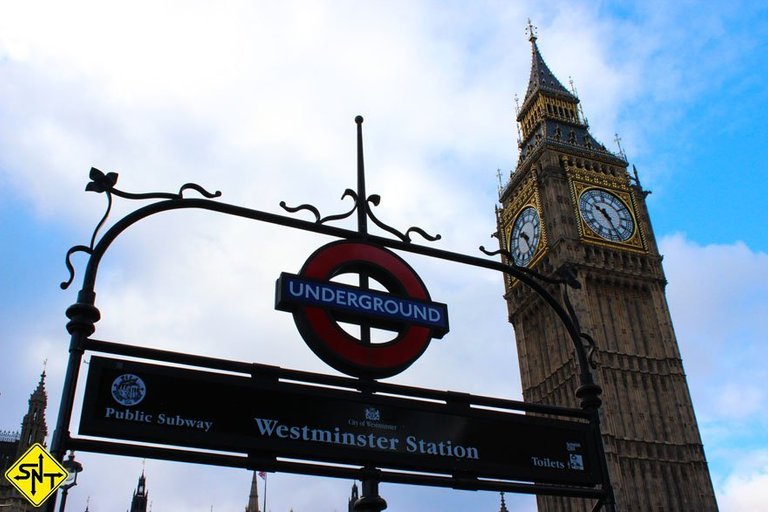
xmin=275 ymin=241 xmax=448 ymax=378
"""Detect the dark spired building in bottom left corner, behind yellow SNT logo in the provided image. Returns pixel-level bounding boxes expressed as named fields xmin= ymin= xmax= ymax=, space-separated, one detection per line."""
xmin=0 ymin=371 xmax=48 ymax=512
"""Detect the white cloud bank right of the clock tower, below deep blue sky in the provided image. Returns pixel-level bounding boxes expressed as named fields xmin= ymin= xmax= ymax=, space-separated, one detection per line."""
xmin=660 ymin=234 xmax=768 ymax=512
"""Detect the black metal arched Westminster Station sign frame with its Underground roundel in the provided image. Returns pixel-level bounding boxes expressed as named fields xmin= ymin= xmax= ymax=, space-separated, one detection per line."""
xmin=47 ymin=116 xmax=615 ymax=512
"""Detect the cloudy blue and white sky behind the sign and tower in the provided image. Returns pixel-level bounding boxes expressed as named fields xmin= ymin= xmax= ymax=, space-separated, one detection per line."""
xmin=0 ymin=1 xmax=768 ymax=512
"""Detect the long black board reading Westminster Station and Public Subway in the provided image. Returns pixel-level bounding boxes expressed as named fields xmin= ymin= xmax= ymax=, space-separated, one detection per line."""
xmin=80 ymin=356 xmax=599 ymax=486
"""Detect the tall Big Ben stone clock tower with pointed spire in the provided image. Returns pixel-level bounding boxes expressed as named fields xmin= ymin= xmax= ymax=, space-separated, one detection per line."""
xmin=498 ymin=23 xmax=717 ymax=512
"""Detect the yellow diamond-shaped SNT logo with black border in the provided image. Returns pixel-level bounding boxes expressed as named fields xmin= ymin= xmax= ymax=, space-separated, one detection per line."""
xmin=5 ymin=443 xmax=69 ymax=507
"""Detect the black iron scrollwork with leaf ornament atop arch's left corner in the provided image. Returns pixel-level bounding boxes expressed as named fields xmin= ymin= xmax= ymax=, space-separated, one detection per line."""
xmin=59 ymin=167 xmax=221 ymax=290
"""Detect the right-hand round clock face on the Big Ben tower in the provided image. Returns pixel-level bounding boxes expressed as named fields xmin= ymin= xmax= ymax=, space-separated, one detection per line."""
xmin=579 ymin=188 xmax=635 ymax=242
